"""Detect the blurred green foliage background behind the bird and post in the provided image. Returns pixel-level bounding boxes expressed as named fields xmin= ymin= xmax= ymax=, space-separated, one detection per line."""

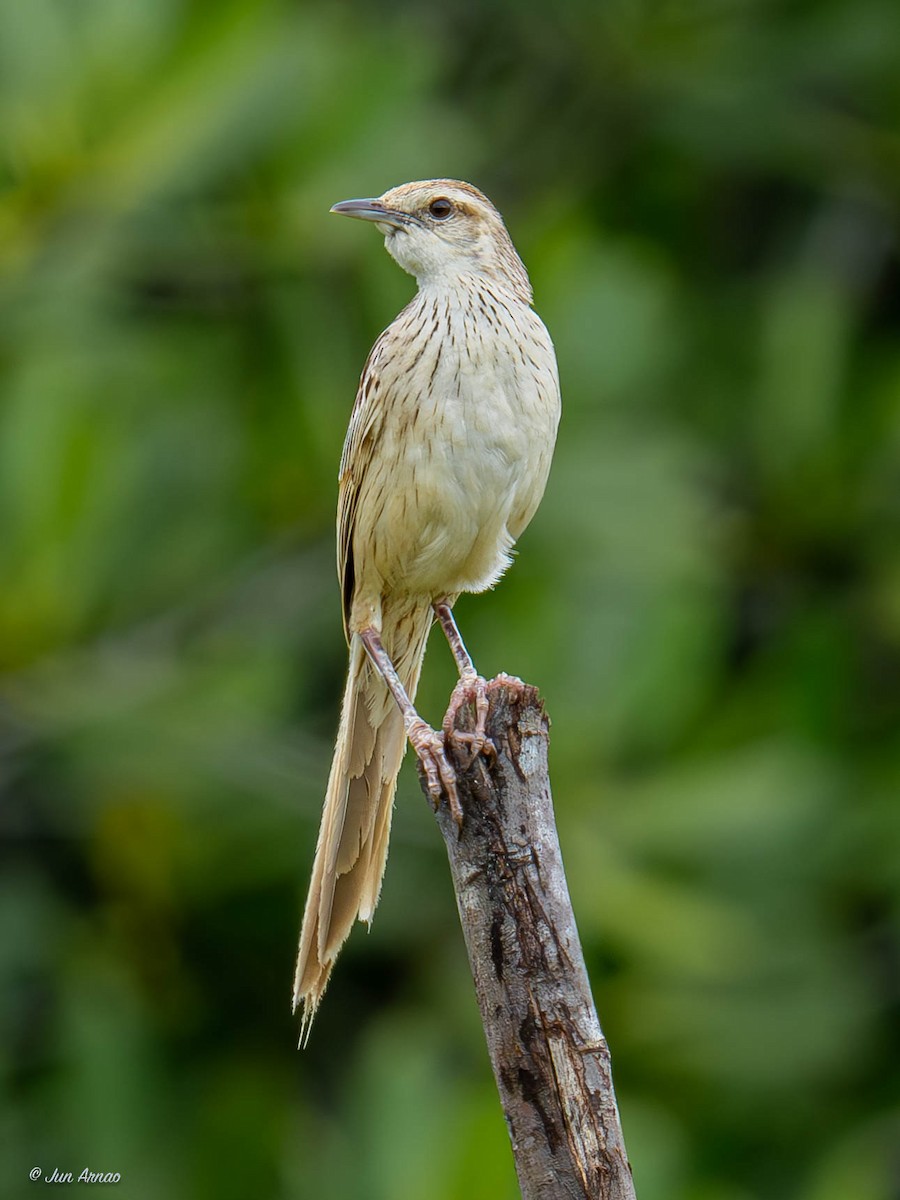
xmin=0 ymin=0 xmax=900 ymax=1200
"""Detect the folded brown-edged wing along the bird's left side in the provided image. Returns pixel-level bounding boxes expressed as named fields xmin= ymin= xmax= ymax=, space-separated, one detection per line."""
xmin=337 ymin=330 xmax=388 ymax=642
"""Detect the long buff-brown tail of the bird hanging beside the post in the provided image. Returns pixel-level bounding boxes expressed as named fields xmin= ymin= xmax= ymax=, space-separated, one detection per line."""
xmin=294 ymin=605 xmax=432 ymax=1042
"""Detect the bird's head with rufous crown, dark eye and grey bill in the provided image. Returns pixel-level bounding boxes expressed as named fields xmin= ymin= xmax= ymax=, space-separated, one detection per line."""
xmin=331 ymin=179 xmax=532 ymax=304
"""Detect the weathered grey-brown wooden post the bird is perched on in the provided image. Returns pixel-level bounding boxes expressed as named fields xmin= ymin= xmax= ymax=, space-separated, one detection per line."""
xmin=427 ymin=676 xmax=635 ymax=1200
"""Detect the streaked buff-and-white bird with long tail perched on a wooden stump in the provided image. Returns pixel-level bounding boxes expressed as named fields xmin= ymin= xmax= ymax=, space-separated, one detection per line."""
xmin=293 ymin=179 xmax=560 ymax=1044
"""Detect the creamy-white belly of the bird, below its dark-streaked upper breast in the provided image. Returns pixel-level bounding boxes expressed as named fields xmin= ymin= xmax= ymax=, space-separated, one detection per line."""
xmin=368 ymin=326 xmax=559 ymax=599
